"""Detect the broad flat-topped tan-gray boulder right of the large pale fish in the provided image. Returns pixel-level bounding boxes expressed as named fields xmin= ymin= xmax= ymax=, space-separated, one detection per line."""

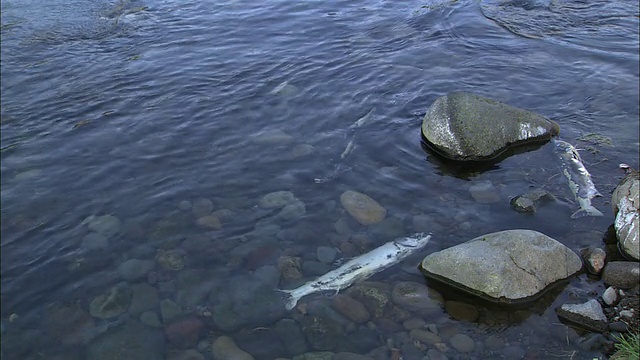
xmin=421 ymin=230 xmax=582 ymax=303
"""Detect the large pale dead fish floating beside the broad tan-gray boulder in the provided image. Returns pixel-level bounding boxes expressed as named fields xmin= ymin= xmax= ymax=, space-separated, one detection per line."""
xmin=280 ymin=233 xmax=431 ymax=310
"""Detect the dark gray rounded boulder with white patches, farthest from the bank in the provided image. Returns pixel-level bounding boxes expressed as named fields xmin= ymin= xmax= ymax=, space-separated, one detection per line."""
xmin=422 ymin=92 xmax=560 ymax=161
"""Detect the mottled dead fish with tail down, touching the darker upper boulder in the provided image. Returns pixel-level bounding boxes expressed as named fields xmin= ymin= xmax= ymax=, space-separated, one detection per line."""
xmin=554 ymin=139 xmax=603 ymax=219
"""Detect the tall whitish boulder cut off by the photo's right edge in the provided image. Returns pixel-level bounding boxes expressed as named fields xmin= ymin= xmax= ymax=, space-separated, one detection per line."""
xmin=611 ymin=171 xmax=640 ymax=261
